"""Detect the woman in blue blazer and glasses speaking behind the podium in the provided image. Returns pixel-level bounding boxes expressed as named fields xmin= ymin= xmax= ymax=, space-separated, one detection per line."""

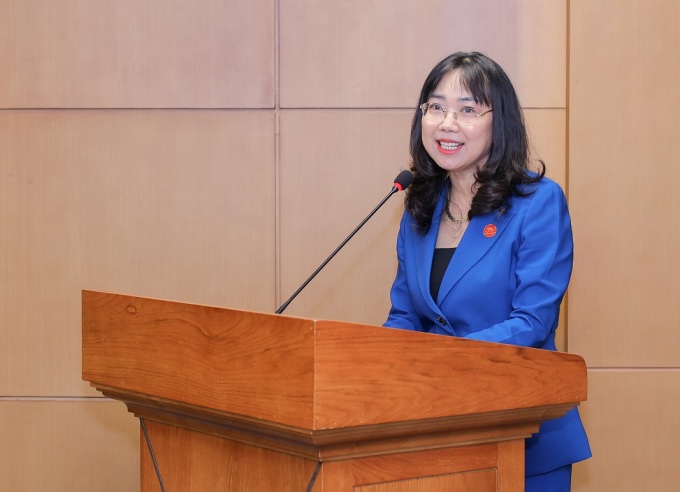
xmin=385 ymin=52 xmax=590 ymax=492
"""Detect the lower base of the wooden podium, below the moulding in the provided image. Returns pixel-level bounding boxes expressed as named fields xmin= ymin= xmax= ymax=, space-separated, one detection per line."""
xmin=141 ymin=421 xmax=524 ymax=492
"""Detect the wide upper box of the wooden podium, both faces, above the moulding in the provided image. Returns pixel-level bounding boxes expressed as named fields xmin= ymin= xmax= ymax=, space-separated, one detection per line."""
xmin=82 ymin=291 xmax=586 ymax=431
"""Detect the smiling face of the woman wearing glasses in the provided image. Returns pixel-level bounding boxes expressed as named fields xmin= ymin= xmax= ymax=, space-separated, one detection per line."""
xmin=421 ymin=70 xmax=493 ymax=176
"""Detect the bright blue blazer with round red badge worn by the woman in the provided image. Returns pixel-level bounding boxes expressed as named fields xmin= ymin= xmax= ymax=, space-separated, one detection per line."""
xmin=385 ymin=178 xmax=591 ymax=475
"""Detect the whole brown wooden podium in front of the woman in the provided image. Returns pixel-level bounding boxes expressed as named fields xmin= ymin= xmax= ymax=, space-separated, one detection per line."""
xmin=83 ymin=291 xmax=586 ymax=492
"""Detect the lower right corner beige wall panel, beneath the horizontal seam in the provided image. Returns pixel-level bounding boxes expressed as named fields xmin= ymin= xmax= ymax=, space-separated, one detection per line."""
xmin=573 ymin=369 xmax=680 ymax=492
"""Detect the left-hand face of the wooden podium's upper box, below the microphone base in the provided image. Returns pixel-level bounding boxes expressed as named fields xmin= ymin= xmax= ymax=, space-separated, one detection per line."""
xmin=83 ymin=292 xmax=314 ymax=427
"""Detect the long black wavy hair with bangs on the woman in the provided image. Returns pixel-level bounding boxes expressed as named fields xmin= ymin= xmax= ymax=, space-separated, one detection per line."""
xmin=405 ymin=51 xmax=545 ymax=233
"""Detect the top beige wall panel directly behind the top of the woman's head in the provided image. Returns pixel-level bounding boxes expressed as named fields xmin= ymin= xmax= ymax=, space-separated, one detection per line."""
xmin=280 ymin=0 xmax=567 ymax=108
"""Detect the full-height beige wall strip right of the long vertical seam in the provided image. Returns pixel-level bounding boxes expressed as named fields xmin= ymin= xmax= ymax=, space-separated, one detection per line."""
xmin=569 ymin=0 xmax=680 ymax=492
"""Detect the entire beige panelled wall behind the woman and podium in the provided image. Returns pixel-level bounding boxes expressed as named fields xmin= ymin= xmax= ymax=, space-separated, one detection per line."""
xmin=0 ymin=0 xmax=680 ymax=492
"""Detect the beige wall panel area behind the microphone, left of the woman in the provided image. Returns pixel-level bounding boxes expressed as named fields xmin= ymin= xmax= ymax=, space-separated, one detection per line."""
xmin=280 ymin=111 xmax=412 ymax=324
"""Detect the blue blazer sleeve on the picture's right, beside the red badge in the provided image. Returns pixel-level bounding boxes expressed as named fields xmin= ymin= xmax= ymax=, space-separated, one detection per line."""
xmin=466 ymin=182 xmax=573 ymax=347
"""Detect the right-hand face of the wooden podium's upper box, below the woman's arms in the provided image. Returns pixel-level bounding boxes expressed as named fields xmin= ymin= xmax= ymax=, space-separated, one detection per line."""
xmin=315 ymin=321 xmax=586 ymax=428
